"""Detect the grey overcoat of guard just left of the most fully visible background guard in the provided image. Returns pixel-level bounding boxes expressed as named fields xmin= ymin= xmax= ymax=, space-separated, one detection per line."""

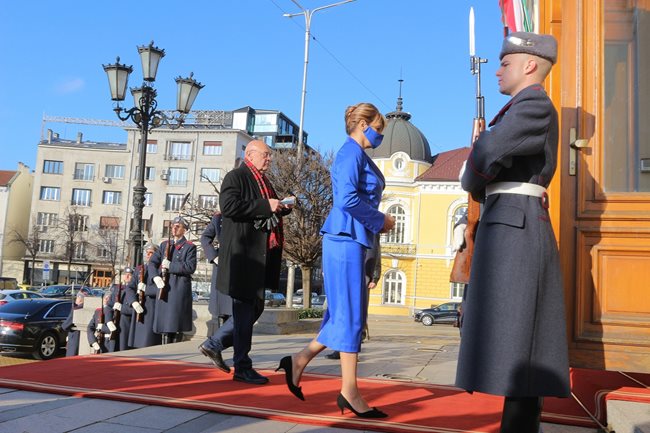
xmin=129 ymin=265 xmax=162 ymax=348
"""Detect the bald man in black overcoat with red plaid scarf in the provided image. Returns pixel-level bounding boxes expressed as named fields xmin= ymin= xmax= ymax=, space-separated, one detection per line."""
xmin=217 ymin=140 xmax=291 ymax=384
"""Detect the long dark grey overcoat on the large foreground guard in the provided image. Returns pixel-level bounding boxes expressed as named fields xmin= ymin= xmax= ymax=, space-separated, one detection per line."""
xmin=456 ymin=85 xmax=569 ymax=397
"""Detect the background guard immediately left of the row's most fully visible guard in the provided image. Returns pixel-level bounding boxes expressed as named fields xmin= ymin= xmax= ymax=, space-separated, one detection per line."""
xmin=129 ymin=243 xmax=162 ymax=348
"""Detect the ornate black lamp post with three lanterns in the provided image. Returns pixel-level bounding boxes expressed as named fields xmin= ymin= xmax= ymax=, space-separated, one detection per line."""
xmin=102 ymin=41 xmax=203 ymax=267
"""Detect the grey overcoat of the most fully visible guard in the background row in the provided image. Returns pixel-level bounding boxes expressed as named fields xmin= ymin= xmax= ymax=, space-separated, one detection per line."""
xmin=147 ymin=237 xmax=196 ymax=334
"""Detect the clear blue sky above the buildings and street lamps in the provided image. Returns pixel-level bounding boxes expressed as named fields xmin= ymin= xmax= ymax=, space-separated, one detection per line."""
xmin=0 ymin=0 xmax=507 ymax=170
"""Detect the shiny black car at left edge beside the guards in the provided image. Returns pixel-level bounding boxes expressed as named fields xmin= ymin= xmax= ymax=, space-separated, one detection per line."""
xmin=0 ymin=298 xmax=72 ymax=359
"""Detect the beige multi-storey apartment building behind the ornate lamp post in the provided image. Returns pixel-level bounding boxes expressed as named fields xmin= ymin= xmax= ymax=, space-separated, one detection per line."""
xmin=25 ymin=107 xmax=307 ymax=286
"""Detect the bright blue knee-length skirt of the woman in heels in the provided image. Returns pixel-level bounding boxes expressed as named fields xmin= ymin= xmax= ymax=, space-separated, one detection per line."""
xmin=316 ymin=234 xmax=368 ymax=352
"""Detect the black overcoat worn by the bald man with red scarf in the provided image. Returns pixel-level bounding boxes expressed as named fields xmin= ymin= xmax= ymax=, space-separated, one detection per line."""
xmin=217 ymin=164 xmax=290 ymax=301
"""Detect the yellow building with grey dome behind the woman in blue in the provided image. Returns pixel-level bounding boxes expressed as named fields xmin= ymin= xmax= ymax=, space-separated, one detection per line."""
xmin=368 ymin=98 xmax=469 ymax=316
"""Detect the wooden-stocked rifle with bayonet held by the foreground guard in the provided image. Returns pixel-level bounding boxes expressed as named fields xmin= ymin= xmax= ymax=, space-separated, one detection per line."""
xmin=449 ymin=8 xmax=487 ymax=284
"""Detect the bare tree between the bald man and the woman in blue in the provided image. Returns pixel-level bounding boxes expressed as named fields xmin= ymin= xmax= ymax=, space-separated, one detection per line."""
xmin=267 ymin=150 xmax=333 ymax=307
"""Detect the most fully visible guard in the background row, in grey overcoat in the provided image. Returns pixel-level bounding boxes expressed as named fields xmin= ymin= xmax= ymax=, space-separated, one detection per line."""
xmin=147 ymin=216 xmax=196 ymax=344
